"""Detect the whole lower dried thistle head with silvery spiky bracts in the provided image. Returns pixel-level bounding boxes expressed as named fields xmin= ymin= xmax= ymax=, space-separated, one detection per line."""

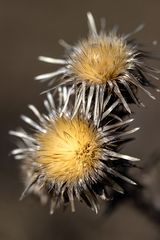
xmin=10 ymin=90 xmax=139 ymax=213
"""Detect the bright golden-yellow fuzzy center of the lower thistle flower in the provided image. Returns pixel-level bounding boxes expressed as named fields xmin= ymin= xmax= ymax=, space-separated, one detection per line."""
xmin=36 ymin=118 xmax=101 ymax=182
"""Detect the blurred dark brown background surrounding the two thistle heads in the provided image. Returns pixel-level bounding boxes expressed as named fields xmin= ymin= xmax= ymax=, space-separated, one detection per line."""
xmin=0 ymin=0 xmax=160 ymax=240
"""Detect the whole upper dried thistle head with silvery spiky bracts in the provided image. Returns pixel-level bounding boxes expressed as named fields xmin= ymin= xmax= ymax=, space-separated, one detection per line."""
xmin=36 ymin=13 xmax=159 ymax=113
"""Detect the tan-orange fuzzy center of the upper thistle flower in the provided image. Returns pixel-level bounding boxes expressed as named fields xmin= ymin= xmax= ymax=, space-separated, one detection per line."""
xmin=72 ymin=35 xmax=128 ymax=84
